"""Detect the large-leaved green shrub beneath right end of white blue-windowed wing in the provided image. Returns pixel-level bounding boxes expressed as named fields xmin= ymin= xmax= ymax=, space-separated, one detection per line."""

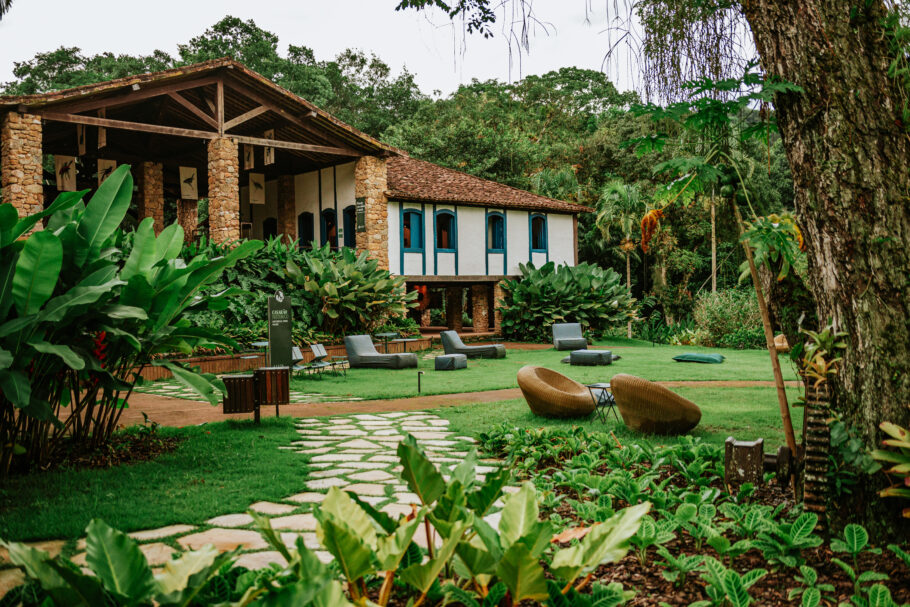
xmin=500 ymin=261 xmax=635 ymax=341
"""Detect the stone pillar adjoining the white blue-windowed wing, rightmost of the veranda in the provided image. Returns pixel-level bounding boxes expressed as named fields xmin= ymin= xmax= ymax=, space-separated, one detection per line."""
xmin=352 ymin=156 xmax=389 ymax=270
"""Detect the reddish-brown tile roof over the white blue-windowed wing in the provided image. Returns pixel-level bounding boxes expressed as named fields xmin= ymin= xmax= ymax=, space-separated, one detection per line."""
xmin=387 ymin=156 xmax=593 ymax=213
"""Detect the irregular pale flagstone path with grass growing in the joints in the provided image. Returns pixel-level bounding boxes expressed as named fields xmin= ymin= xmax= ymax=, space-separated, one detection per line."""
xmin=0 ymin=412 xmax=506 ymax=596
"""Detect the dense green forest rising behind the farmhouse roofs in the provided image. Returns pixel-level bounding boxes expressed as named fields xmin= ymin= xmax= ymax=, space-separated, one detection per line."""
xmin=2 ymin=17 xmax=793 ymax=322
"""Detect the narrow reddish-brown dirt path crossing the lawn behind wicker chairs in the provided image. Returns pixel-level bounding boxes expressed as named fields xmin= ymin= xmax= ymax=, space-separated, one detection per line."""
xmin=120 ymin=380 xmax=802 ymax=427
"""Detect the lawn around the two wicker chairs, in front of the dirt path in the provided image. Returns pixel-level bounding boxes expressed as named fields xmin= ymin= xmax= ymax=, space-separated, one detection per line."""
xmin=433 ymin=388 xmax=803 ymax=451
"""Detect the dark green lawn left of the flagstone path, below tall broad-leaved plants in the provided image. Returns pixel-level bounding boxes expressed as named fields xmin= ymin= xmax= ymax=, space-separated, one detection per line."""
xmin=0 ymin=417 xmax=309 ymax=540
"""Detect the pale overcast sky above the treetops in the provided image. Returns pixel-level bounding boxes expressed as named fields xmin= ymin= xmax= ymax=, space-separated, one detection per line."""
xmin=0 ymin=0 xmax=631 ymax=93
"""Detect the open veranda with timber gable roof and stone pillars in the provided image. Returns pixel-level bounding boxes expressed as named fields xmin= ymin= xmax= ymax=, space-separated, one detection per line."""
xmin=0 ymin=59 xmax=394 ymax=249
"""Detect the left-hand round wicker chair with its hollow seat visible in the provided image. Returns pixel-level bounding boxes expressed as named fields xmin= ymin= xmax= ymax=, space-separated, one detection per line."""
xmin=518 ymin=365 xmax=594 ymax=417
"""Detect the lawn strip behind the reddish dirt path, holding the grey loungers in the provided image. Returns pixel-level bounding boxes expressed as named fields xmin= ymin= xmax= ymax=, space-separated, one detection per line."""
xmin=291 ymin=339 xmax=796 ymax=399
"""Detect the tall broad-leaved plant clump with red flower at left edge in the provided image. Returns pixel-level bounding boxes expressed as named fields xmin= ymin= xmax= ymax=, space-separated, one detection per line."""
xmin=0 ymin=165 xmax=262 ymax=476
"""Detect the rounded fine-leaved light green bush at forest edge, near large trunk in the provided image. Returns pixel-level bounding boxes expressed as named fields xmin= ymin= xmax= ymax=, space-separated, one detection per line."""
xmin=692 ymin=289 xmax=765 ymax=349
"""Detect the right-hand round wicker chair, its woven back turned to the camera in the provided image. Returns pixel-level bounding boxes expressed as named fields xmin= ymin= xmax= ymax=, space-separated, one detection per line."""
xmin=610 ymin=373 xmax=701 ymax=434
